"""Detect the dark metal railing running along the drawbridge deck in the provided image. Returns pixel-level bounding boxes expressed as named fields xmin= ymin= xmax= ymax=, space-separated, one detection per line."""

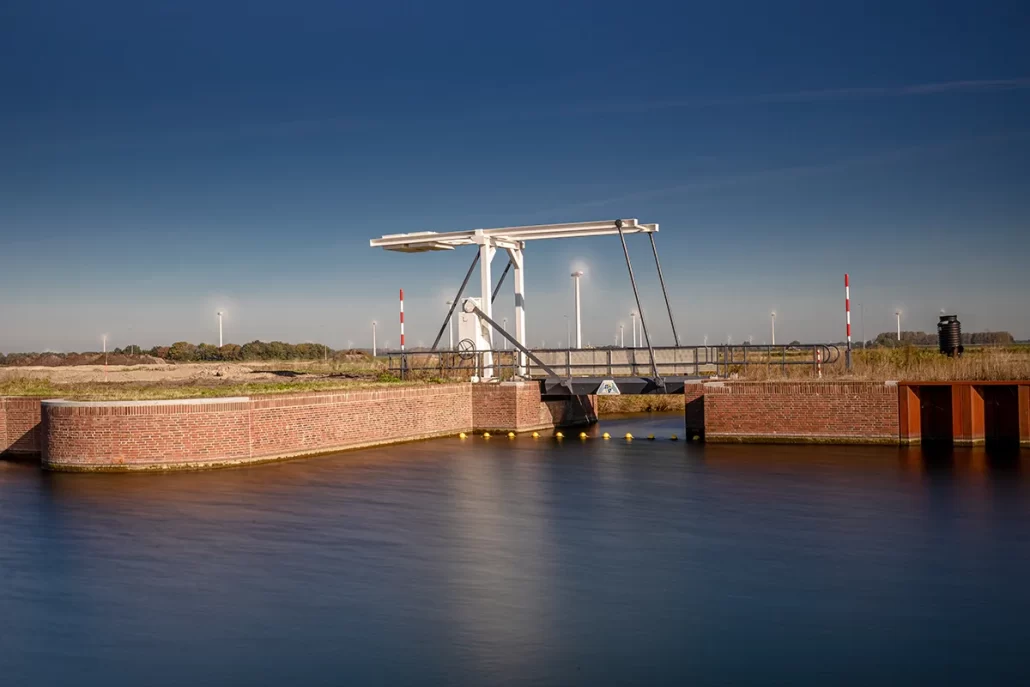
xmin=379 ymin=344 xmax=840 ymax=380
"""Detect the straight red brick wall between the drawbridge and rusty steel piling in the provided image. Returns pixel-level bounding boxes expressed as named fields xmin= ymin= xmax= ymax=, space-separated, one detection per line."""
xmin=700 ymin=382 xmax=899 ymax=444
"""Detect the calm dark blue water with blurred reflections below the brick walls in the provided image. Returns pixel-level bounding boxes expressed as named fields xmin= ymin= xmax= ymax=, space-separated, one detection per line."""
xmin=0 ymin=416 xmax=1030 ymax=687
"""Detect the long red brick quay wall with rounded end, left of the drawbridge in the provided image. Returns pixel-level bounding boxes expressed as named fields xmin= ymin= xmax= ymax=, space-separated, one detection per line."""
xmin=42 ymin=383 xmax=596 ymax=471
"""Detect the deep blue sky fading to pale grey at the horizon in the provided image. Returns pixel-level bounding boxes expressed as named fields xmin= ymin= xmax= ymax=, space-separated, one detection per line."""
xmin=0 ymin=0 xmax=1030 ymax=350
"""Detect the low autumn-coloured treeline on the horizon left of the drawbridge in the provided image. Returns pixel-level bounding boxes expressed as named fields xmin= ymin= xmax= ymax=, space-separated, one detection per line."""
xmin=0 ymin=341 xmax=366 ymax=366
